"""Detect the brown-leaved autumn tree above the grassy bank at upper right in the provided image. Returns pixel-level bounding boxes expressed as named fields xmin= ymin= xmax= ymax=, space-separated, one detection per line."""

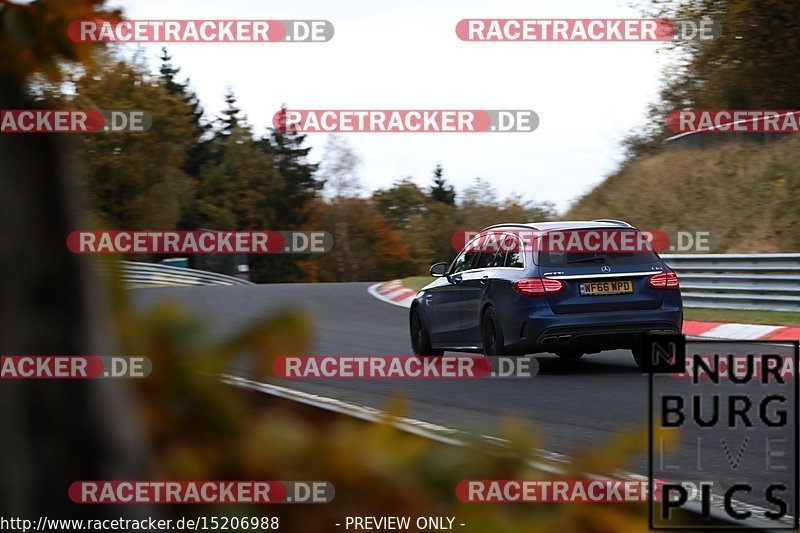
xmin=624 ymin=0 xmax=800 ymax=158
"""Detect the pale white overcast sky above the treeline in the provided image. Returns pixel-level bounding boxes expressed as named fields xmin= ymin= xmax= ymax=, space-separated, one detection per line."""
xmin=111 ymin=0 xmax=665 ymax=210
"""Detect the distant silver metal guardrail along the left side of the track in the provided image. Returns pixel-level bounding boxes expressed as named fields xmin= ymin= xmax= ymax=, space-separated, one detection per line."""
xmin=97 ymin=261 xmax=253 ymax=286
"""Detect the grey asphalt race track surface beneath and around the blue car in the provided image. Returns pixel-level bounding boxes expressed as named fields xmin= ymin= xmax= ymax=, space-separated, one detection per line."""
xmin=132 ymin=283 xmax=797 ymax=514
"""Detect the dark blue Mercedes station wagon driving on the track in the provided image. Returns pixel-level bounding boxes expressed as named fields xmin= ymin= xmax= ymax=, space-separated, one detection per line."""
xmin=409 ymin=220 xmax=683 ymax=366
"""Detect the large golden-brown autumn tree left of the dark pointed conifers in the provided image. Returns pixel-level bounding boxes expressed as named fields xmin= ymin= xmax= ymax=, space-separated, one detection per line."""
xmin=48 ymin=51 xmax=198 ymax=229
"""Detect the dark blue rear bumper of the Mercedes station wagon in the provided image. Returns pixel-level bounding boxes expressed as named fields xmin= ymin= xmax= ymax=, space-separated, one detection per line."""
xmin=506 ymin=307 xmax=683 ymax=353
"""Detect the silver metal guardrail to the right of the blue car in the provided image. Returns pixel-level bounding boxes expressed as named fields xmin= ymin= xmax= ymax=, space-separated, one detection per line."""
xmin=661 ymin=254 xmax=800 ymax=312
